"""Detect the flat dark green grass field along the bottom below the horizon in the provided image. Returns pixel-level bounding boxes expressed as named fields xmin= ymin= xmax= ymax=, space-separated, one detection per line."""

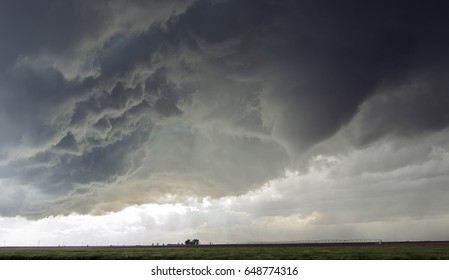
xmin=0 ymin=242 xmax=449 ymax=260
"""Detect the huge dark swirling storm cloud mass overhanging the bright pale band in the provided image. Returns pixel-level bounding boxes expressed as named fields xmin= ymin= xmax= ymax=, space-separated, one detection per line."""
xmin=0 ymin=0 xmax=449 ymax=216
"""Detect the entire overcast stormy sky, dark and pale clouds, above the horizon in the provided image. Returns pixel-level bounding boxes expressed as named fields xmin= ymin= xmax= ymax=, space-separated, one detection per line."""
xmin=0 ymin=0 xmax=449 ymax=245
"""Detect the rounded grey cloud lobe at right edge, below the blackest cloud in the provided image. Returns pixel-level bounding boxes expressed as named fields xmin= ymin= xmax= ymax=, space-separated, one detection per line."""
xmin=347 ymin=74 xmax=449 ymax=146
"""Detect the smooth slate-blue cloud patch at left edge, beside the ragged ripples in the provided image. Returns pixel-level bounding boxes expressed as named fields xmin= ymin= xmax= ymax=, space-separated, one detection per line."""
xmin=0 ymin=68 xmax=68 ymax=153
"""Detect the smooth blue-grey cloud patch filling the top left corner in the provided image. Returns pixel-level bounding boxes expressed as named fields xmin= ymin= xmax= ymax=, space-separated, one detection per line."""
xmin=0 ymin=0 xmax=105 ymax=65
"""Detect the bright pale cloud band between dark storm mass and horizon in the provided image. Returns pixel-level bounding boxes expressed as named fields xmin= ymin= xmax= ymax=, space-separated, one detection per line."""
xmin=0 ymin=128 xmax=449 ymax=245
